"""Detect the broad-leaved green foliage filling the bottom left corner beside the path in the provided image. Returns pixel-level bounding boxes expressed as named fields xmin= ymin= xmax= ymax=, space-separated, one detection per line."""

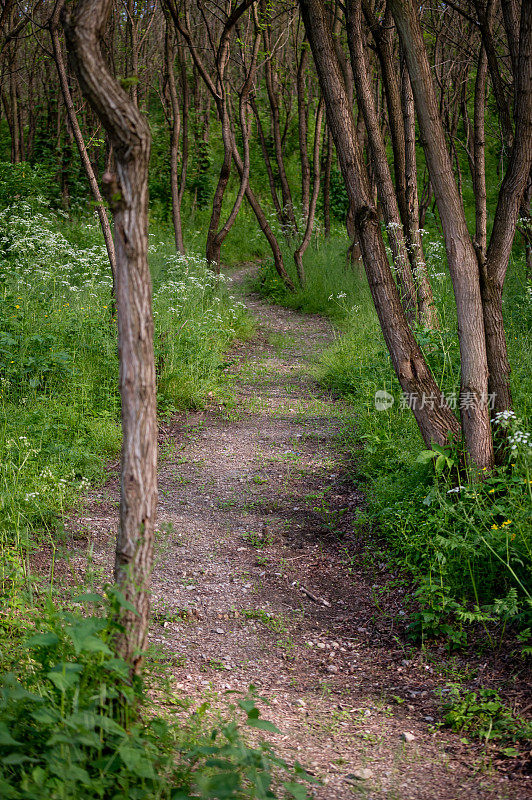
xmin=0 ymin=588 xmax=313 ymax=800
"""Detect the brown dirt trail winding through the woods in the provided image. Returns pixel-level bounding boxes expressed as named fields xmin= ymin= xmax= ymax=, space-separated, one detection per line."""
xmin=70 ymin=272 xmax=530 ymax=800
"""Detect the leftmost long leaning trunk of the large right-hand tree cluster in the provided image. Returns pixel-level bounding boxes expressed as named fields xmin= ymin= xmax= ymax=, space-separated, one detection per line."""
xmin=300 ymin=0 xmax=460 ymax=445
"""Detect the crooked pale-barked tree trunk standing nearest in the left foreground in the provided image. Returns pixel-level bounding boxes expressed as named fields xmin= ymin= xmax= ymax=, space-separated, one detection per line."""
xmin=63 ymin=0 xmax=157 ymax=672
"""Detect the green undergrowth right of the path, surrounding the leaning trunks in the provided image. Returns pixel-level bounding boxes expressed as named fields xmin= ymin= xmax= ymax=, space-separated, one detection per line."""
xmin=257 ymin=225 xmax=532 ymax=653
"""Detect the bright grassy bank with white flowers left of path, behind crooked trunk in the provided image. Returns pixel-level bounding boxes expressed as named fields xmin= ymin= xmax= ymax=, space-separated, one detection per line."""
xmin=0 ymin=188 xmax=250 ymax=546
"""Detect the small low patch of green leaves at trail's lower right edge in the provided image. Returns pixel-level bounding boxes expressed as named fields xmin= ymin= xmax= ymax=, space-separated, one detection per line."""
xmin=442 ymin=684 xmax=532 ymax=744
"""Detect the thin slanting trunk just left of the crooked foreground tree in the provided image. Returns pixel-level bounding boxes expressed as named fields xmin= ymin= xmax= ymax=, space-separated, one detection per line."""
xmin=48 ymin=0 xmax=116 ymax=290
